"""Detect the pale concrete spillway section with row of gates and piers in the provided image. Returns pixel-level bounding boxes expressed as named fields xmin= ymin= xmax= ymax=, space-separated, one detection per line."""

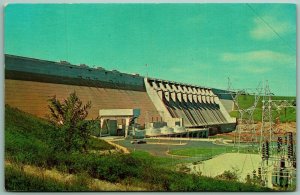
xmin=144 ymin=78 xmax=236 ymax=132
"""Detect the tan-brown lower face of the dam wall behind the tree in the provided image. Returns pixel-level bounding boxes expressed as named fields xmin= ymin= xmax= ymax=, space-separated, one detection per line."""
xmin=5 ymin=79 xmax=161 ymax=124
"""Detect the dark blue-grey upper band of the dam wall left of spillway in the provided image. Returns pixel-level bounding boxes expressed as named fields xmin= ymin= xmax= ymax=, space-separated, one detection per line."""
xmin=5 ymin=55 xmax=145 ymax=91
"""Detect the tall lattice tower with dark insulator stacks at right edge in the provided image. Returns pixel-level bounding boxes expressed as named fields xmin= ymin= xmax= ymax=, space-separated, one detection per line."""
xmin=260 ymin=81 xmax=296 ymax=187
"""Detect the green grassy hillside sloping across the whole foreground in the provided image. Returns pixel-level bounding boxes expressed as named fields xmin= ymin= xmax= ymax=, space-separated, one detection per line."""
xmin=5 ymin=106 xmax=270 ymax=191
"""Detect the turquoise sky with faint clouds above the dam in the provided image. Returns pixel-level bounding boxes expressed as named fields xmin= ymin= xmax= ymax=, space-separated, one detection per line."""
xmin=4 ymin=4 xmax=296 ymax=96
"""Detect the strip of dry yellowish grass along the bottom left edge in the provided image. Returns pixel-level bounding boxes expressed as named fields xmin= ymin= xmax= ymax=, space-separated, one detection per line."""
xmin=5 ymin=162 xmax=145 ymax=192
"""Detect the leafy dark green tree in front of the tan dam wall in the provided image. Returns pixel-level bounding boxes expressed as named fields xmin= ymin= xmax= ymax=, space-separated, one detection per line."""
xmin=48 ymin=92 xmax=91 ymax=153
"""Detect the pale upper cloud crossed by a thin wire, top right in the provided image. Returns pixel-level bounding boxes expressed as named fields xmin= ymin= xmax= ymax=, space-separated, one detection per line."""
xmin=250 ymin=16 xmax=296 ymax=41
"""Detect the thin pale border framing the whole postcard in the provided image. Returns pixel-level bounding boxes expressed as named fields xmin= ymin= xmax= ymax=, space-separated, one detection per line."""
xmin=0 ymin=0 xmax=300 ymax=194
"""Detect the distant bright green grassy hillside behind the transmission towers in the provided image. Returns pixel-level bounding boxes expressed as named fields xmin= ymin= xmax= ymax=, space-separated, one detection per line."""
xmin=230 ymin=95 xmax=296 ymax=122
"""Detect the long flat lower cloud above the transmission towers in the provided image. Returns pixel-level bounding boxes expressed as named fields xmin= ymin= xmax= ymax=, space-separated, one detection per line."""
xmin=221 ymin=50 xmax=296 ymax=66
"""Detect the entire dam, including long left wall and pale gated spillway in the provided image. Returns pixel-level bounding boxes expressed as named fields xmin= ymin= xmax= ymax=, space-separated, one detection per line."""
xmin=5 ymin=55 xmax=236 ymax=134
